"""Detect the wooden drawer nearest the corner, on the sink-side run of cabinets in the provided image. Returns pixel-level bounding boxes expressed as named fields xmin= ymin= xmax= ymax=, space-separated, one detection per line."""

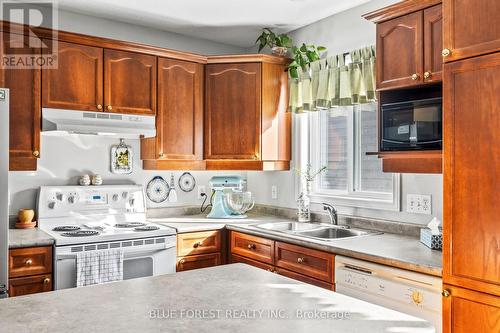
xmin=231 ymin=232 xmax=274 ymax=265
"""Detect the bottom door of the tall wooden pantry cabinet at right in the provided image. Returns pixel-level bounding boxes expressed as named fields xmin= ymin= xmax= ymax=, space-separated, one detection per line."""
xmin=443 ymin=285 xmax=500 ymax=333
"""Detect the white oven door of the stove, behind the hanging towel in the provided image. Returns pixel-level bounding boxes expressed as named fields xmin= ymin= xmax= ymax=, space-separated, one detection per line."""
xmin=54 ymin=237 xmax=177 ymax=290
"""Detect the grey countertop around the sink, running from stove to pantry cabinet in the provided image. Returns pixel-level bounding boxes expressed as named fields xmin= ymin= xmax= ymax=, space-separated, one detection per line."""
xmin=155 ymin=215 xmax=442 ymax=277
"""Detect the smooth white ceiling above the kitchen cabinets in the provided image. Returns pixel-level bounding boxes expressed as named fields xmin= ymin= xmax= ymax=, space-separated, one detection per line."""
xmin=55 ymin=0 xmax=369 ymax=47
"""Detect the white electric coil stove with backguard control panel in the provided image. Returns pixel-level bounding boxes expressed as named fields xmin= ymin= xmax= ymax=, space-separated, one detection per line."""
xmin=38 ymin=185 xmax=176 ymax=289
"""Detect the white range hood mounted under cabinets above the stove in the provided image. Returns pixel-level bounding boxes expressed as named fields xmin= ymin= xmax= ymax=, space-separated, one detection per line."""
xmin=42 ymin=108 xmax=156 ymax=139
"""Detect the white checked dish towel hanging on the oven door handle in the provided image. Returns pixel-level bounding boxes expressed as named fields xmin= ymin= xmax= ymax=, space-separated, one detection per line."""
xmin=76 ymin=249 xmax=123 ymax=287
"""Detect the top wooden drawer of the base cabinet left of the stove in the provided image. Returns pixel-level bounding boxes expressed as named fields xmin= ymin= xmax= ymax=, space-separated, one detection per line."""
xmin=9 ymin=246 xmax=52 ymax=277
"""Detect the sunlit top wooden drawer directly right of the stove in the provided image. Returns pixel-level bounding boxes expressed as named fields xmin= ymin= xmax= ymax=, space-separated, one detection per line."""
xmin=177 ymin=230 xmax=221 ymax=257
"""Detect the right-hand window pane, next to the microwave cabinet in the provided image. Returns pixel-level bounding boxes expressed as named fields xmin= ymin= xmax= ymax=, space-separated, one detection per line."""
xmin=356 ymin=103 xmax=392 ymax=193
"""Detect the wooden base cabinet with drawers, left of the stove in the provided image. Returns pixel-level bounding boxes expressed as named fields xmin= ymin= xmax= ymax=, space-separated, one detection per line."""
xmin=9 ymin=246 xmax=53 ymax=297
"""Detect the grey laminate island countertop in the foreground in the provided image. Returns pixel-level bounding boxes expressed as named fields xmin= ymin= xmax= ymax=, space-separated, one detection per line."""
xmin=0 ymin=264 xmax=434 ymax=333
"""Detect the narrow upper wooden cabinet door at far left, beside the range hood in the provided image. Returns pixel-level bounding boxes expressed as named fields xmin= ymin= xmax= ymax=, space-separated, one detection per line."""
xmin=0 ymin=33 xmax=41 ymax=171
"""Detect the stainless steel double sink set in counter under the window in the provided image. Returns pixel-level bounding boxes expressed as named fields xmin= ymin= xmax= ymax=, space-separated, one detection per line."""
xmin=254 ymin=222 xmax=380 ymax=241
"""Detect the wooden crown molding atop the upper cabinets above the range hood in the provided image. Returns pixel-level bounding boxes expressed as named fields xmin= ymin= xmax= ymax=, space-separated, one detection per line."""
xmin=0 ymin=21 xmax=207 ymax=64
